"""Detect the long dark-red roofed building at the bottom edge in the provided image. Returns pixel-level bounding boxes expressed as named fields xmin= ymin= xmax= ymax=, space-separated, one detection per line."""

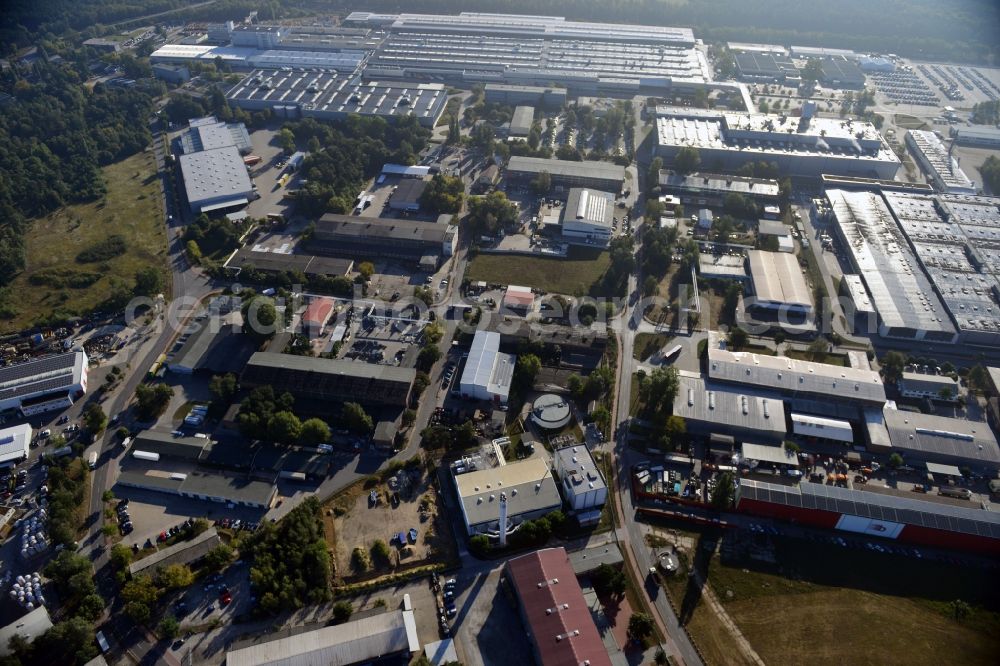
xmin=507 ymin=548 xmax=611 ymax=666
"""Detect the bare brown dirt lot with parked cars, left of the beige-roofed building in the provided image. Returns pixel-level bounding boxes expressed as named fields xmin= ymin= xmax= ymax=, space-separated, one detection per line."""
xmin=324 ymin=468 xmax=454 ymax=583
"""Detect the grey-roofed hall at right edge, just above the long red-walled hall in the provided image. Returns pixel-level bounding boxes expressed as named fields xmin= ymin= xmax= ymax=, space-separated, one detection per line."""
xmin=882 ymin=408 xmax=1000 ymax=466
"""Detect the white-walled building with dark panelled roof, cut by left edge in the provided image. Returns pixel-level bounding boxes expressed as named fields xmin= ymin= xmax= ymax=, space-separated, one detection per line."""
xmin=0 ymin=350 xmax=89 ymax=416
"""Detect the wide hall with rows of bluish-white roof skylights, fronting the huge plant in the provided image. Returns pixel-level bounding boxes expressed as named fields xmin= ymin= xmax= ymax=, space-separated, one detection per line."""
xmin=226 ymin=67 xmax=448 ymax=127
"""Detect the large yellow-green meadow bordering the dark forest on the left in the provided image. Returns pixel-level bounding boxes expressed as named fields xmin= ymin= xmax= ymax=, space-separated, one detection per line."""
xmin=0 ymin=152 xmax=169 ymax=331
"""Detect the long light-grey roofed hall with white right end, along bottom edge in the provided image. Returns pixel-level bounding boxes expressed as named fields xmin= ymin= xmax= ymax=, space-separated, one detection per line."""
xmin=226 ymin=610 xmax=420 ymax=666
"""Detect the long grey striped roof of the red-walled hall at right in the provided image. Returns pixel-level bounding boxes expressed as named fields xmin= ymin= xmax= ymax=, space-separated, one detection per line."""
xmin=740 ymin=479 xmax=1000 ymax=539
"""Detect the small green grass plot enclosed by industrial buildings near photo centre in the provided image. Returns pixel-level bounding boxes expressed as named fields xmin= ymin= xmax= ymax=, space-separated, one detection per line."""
xmin=465 ymin=247 xmax=611 ymax=296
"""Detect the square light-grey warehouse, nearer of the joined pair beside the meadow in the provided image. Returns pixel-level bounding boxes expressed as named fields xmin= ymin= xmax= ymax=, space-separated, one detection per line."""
xmin=178 ymin=146 xmax=254 ymax=213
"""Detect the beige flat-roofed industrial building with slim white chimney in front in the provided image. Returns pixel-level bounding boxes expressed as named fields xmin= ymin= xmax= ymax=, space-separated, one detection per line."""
xmin=454 ymin=458 xmax=562 ymax=536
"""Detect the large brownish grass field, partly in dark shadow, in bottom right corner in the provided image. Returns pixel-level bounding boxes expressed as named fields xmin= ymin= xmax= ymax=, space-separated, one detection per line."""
xmin=648 ymin=512 xmax=1000 ymax=666
